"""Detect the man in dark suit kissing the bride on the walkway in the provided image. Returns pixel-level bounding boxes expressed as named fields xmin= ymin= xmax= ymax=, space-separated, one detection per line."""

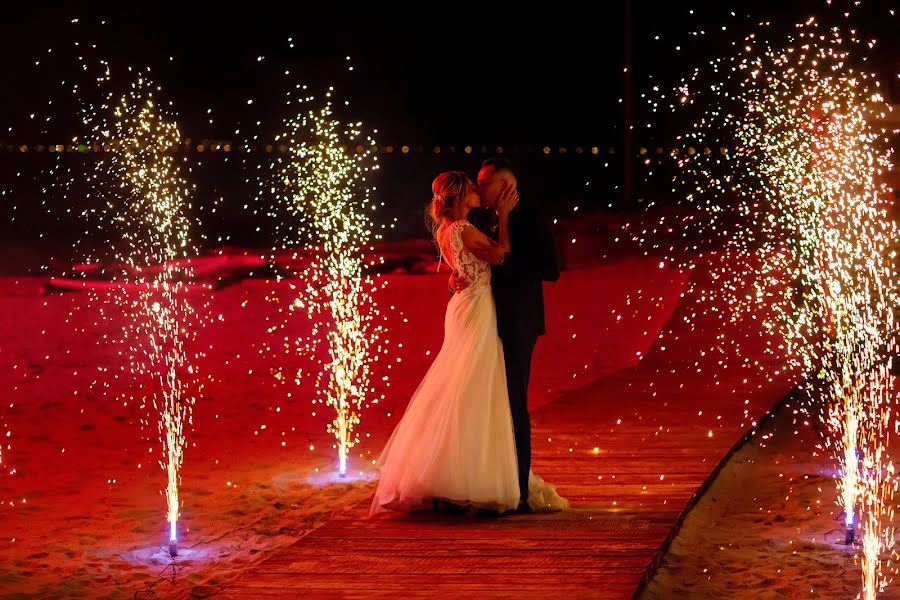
xmin=450 ymin=157 xmax=559 ymax=512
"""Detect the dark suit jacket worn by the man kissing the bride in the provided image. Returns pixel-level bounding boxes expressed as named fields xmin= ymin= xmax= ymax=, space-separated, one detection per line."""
xmin=468 ymin=199 xmax=559 ymax=340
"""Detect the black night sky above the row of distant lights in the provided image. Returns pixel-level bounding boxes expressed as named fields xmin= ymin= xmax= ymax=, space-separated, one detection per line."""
xmin=0 ymin=0 xmax=900 ymax=145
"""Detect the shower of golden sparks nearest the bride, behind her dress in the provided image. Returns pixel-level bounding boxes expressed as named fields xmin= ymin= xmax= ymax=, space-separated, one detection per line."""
xmin=264 ymin=86 xmax=386 ymax=474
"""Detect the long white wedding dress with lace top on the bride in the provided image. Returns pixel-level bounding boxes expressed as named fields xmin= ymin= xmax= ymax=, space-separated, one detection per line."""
xmin=370 ymin=221 xmax=568 ymax=515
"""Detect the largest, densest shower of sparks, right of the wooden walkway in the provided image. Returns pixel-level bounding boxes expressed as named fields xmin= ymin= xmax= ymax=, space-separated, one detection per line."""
xmin=640 ymin=19 xmax=900 ymax=599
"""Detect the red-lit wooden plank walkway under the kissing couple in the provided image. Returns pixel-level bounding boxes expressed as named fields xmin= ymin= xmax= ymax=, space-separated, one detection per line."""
xmin=216 ymin=264 xmax=789 ymax=598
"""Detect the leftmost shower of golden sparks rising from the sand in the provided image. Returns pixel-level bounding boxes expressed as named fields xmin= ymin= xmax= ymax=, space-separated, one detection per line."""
xmin=69 ymin=68 xmax=202 ymax=542
